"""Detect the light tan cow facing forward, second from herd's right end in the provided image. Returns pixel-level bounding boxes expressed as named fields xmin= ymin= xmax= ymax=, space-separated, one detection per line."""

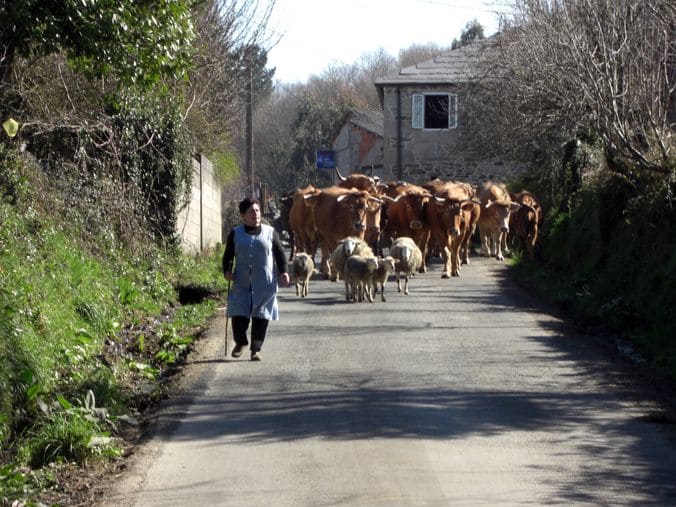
xmin=477 ymin=181 xmax=520 ymax=261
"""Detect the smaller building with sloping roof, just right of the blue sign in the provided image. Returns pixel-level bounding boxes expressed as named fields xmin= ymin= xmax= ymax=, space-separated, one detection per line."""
xmin=333 ymin=109 xmax=383 ymax=177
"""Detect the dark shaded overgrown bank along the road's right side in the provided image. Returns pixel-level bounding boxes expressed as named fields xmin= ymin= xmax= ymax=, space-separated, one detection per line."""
xmin=516 ymin=147 xmax=676 ymax=379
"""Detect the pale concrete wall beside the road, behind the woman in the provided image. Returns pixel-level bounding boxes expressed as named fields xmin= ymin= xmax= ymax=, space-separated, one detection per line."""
xmin=177 ymin=154 xmax=224 ymax=254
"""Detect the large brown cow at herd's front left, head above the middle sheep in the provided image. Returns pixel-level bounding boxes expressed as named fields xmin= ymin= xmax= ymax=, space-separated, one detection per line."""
xmin=305 ymin=187 xmax=382 ymax=277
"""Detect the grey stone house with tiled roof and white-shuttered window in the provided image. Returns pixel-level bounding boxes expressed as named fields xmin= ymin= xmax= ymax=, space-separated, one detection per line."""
xmin=375 ymin=37 xmax=523 ymax=183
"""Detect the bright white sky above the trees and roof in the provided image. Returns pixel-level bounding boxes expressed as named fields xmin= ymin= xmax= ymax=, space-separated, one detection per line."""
xmin=268 ymin=0 xmax=504 ymax=83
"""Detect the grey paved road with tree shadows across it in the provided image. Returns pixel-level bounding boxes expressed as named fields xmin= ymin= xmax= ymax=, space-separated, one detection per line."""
xmin=103 ymin=258 xmax=676 ymax=506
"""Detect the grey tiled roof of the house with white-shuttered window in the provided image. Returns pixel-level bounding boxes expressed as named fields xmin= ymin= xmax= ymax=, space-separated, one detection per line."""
xmin=375 ymin=39 xmax=488 ymax=88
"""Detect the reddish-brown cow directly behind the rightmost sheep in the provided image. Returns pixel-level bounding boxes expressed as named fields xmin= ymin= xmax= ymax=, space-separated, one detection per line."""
xmin=385 ymin=185 xmax=433 ymax=273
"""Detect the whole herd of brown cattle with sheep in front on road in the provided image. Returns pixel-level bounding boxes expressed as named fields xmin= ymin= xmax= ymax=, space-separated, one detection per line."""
xmin=280 ymin=171 xmax=542 ymax=301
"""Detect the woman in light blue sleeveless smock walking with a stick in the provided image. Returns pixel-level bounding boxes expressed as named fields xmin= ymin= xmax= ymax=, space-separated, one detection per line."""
xmin=223 ymin=197 xmax=289 ymax=361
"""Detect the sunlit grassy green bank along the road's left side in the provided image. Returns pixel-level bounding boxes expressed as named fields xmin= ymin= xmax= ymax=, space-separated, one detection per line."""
xmin=0 ymin=144 xmax=224 ymax=504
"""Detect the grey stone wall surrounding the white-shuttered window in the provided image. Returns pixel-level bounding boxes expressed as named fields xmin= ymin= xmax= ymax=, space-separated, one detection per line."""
xmin=383 ymin=86 xmax=524 ymax=184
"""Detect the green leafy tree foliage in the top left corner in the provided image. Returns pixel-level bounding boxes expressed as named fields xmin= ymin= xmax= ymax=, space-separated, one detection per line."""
xmin=0 ymin=0 xmax=194 ymax=95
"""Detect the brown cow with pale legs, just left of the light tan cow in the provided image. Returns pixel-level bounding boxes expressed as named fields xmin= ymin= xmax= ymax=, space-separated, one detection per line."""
xmin=425 ymin=183 xmax=476 ymax=278
